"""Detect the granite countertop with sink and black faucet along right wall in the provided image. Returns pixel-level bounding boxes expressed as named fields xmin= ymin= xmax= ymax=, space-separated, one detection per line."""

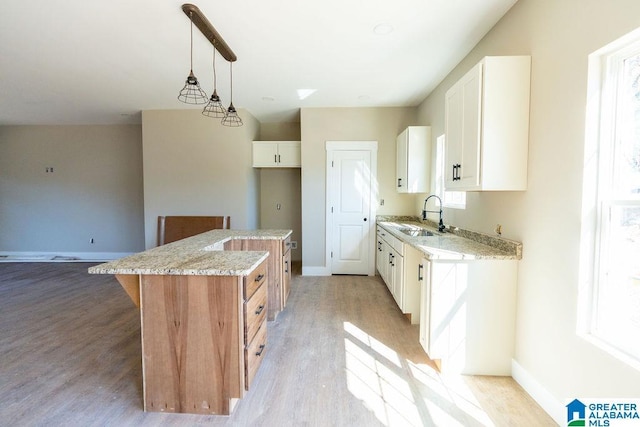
xmin=377 ymin=217 xmax=522 ymax=260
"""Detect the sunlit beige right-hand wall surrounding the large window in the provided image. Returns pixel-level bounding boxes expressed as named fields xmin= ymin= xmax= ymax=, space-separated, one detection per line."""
xmin=415 ymin=0 xmax=640 ymax=423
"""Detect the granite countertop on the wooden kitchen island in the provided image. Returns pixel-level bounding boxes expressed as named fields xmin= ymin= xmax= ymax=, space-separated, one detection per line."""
xmin=89 ymin=230 xmax=292 ymax=276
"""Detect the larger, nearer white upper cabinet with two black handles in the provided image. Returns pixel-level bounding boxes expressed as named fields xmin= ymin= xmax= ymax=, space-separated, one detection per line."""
xmin=444 ymin=56 xmax=531 ymax=191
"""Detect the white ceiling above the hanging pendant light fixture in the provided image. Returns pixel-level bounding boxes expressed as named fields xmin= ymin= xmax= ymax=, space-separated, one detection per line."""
xmin=0 ymin=0 xmax=516 ymax=125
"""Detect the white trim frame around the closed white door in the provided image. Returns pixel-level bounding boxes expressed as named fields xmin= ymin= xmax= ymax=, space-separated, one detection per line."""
xmin=324 ymin=141 xmax=378 ymax=276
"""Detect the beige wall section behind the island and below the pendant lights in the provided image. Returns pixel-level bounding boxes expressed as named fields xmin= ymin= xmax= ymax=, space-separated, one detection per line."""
xmin=142 ymin=109 xmax=260 ymax=248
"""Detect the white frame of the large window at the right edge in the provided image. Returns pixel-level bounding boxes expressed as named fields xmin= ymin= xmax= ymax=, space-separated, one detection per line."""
xmin=578 ymin=29 xmax=640 ymax=369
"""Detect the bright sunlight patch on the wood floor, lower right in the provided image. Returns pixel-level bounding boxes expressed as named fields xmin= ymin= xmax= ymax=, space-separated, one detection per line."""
xmin=344 ymin=322 xmax=494 ymax=426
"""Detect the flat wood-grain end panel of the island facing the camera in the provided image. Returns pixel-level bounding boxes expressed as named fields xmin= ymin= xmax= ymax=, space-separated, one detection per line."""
xmin=140 ymin=276 xmax=245 ymax=415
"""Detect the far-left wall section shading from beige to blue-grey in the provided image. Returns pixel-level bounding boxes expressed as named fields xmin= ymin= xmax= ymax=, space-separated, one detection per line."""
xmin=0 ymin=125 xmax=144 ymax=259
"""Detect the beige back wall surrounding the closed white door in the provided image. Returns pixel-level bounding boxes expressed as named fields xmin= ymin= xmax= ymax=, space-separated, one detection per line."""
xmin=300 ymin=108 xmax=417 ymax=272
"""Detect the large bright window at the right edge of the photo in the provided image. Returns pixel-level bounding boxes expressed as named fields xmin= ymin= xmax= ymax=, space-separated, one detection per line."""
xmin=583 ymin=30 xmax=640 ymax=362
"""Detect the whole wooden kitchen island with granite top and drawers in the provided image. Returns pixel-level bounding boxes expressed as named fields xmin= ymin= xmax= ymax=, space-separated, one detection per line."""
xmin=89 ymin=230 xmax=291 ymax=415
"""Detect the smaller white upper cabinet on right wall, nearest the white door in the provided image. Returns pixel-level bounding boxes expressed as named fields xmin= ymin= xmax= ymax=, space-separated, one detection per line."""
xmin=396 ymin=126 xmax=431 ymax=193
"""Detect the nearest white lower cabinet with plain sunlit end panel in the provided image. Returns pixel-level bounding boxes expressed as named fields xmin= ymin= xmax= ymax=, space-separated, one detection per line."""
xmin=420 ymin=259 xmax=517 ymax=375
